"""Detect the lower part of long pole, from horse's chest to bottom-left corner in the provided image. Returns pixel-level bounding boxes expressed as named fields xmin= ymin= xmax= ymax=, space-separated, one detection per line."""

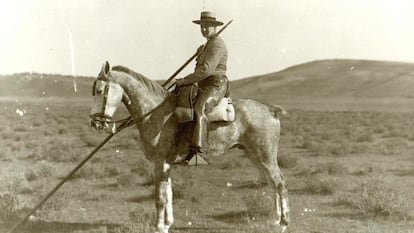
xmin=7 ymin=118 xmax=134 ymax=233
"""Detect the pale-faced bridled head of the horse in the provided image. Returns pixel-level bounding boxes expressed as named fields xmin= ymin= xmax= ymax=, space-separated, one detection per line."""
xmin=90 ymin=62 xmax=127 ymax=130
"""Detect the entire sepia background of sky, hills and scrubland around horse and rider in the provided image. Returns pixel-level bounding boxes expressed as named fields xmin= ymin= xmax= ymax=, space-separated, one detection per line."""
xmin=0 ymin=0 xmax=414 ymax=233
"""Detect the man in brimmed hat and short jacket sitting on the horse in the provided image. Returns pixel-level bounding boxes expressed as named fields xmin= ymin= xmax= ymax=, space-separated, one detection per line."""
xmin=176 ymin=11 xmax=228 ymax=164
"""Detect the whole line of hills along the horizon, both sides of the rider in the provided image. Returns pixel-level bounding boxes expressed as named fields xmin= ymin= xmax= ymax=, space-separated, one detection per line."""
xmin=0 ymin=59 xmax=414 ymax=110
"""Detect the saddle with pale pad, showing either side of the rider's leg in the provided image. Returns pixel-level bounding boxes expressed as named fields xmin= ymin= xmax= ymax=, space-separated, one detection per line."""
xmin=174 ymin=85 xmax=236 ymax=123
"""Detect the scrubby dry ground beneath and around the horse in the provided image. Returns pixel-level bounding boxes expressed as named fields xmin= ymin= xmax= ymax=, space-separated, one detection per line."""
xmin=0 ymin=101 xmax=414 ymax=233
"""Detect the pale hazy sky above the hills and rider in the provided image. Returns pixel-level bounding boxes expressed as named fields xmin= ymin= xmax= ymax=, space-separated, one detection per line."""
xmin=0 ymin=0 xmax=414 ymax=80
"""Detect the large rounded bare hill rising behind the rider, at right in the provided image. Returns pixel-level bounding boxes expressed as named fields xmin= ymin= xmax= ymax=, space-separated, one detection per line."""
xmin=231 ymin=60 xmax=414 ymax=99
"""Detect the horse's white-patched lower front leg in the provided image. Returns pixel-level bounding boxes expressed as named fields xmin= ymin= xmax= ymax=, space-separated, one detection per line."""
xmin=154 ymin=161 xmax=174 ymax=233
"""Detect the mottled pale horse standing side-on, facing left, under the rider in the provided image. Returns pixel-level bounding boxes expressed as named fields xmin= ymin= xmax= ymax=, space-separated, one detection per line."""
xmin=90 ymin=62 xmax=289 ymax=233
